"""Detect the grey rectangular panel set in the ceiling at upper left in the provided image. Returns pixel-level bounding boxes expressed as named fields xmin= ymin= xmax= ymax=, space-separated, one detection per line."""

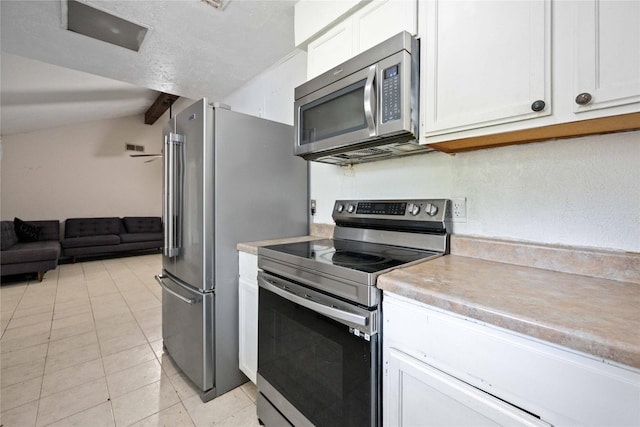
xmin=67 ymin=0 xmax=149 ymax=52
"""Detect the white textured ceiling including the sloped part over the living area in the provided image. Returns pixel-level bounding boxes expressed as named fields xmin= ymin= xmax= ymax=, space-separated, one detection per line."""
xmin=0 ymin=0 xmax=295 ymax=135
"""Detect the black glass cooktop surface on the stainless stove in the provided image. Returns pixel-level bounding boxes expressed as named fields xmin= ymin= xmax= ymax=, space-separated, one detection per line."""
xmin=264 ymin=239 xmax=442 ymax=273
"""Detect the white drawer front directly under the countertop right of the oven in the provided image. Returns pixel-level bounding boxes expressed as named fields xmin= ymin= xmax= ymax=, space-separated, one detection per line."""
xmin=383 ymin=294 xmax=640 ymax=426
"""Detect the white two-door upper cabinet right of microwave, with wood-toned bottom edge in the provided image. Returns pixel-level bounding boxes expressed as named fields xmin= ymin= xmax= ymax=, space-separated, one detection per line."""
xmin=418 ymin=0 xmax=640 ymax=152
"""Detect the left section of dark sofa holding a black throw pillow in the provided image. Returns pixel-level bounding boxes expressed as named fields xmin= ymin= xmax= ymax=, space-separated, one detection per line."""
xmin=0 ymin=219 xmax=60 ymax=281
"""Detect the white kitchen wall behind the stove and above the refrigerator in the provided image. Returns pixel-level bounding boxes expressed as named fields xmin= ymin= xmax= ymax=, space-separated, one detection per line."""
xmin=224 ymin=52 xmax=640 ymax=252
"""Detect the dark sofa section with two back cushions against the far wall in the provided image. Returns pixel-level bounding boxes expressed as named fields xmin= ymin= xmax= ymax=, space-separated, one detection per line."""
xmin=60 ymin=217 xmax=163 ymax=261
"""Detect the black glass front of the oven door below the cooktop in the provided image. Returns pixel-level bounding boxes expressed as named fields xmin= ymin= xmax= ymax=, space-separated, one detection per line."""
xmin=258 ymin=288 xmax=378 ymax=426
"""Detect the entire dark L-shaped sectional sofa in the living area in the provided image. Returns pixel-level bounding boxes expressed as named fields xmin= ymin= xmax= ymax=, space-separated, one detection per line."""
xmin=0 ymin=217 xmax=164 ymax=281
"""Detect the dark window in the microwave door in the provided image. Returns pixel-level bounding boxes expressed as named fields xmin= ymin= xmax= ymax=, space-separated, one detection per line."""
xmin=300 ymin=80 xmax=367 ymax=145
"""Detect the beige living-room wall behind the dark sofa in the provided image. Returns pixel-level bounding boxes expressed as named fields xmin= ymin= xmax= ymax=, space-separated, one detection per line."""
xmin=0 ymin=99 xmax=190 ymax=221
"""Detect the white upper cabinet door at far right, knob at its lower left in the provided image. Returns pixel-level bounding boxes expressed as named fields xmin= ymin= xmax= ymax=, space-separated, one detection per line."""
xmin=574 ymin=0 xmax=640 ymax=115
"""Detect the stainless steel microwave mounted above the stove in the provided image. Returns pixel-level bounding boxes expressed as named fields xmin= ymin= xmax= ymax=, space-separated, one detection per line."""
xmin=294 ymin=32 xmax=432 ymax=165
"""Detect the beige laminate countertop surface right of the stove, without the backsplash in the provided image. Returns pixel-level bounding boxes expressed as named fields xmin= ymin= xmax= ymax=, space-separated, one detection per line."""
xmin=377 ymin=255 xmax=640 ymax=369
